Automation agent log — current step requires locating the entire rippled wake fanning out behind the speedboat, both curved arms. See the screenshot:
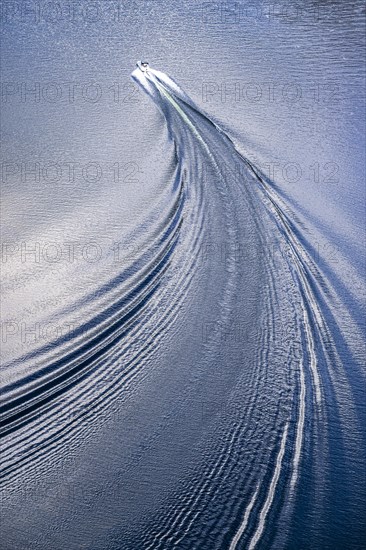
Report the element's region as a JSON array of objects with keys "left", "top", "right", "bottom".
[{"left": 0, "top": 63, "right": 365, "bottom": 550}]
